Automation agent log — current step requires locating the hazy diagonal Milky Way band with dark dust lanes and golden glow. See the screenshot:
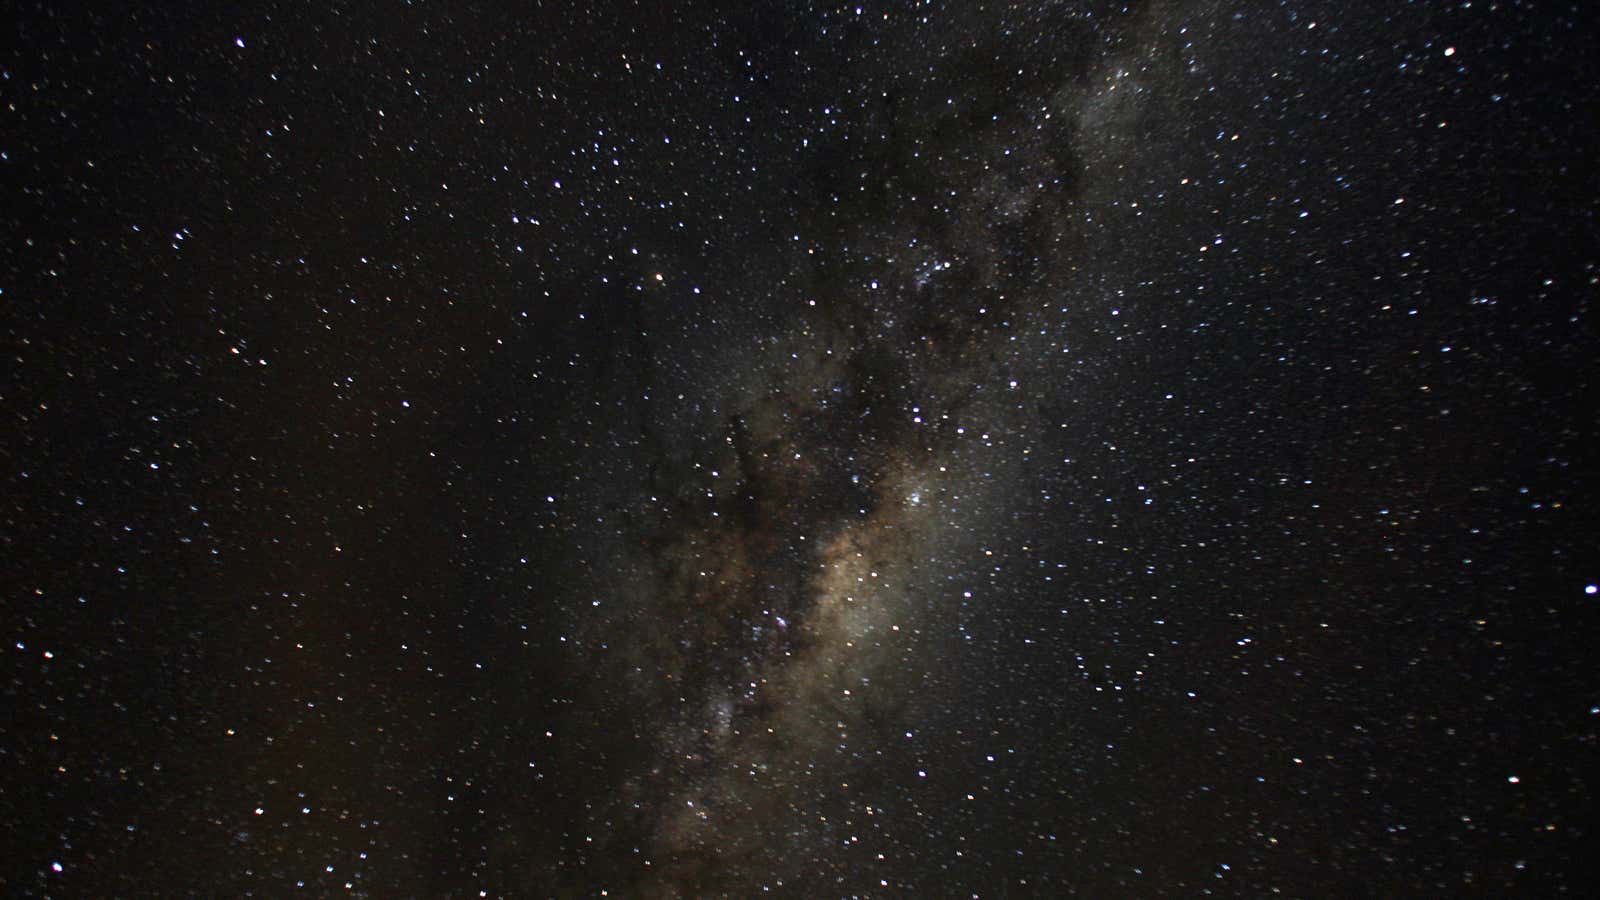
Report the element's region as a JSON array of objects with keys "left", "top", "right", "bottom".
[{"left": 550, "top": 11, "right": 1174, "bottom": 894}]
